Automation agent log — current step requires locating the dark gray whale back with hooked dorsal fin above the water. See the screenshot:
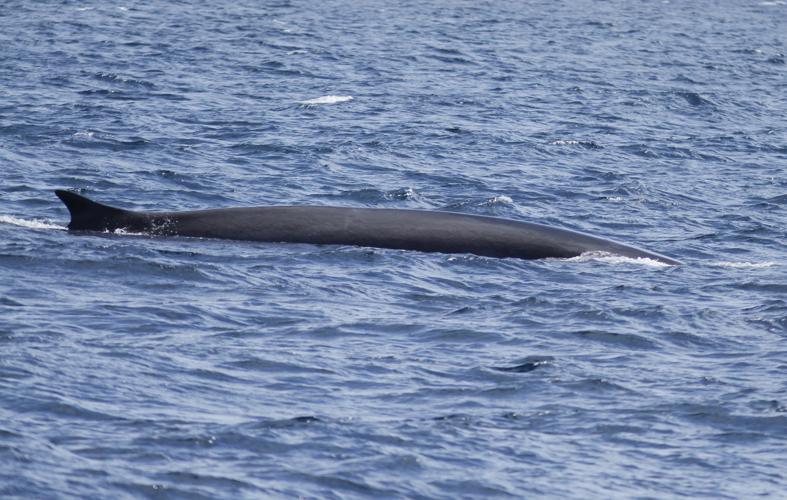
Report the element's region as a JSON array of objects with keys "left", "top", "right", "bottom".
[{"left": 55, "top": 190, "right": 680, "bottom": 265}]
